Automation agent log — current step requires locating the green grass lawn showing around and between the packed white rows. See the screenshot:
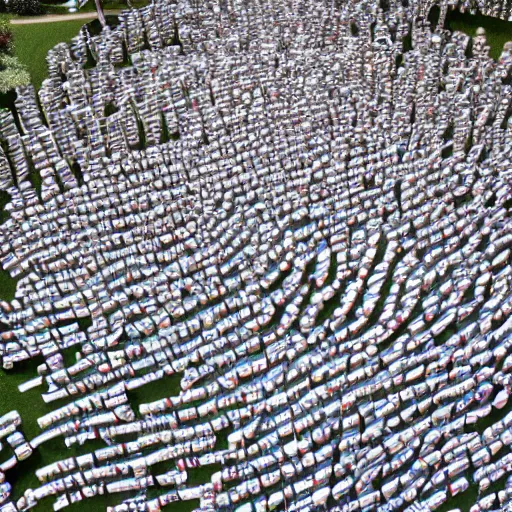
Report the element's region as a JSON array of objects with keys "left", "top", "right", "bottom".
[{"left": 0, "top": 7, "right": 512, "bottom": 512}]
